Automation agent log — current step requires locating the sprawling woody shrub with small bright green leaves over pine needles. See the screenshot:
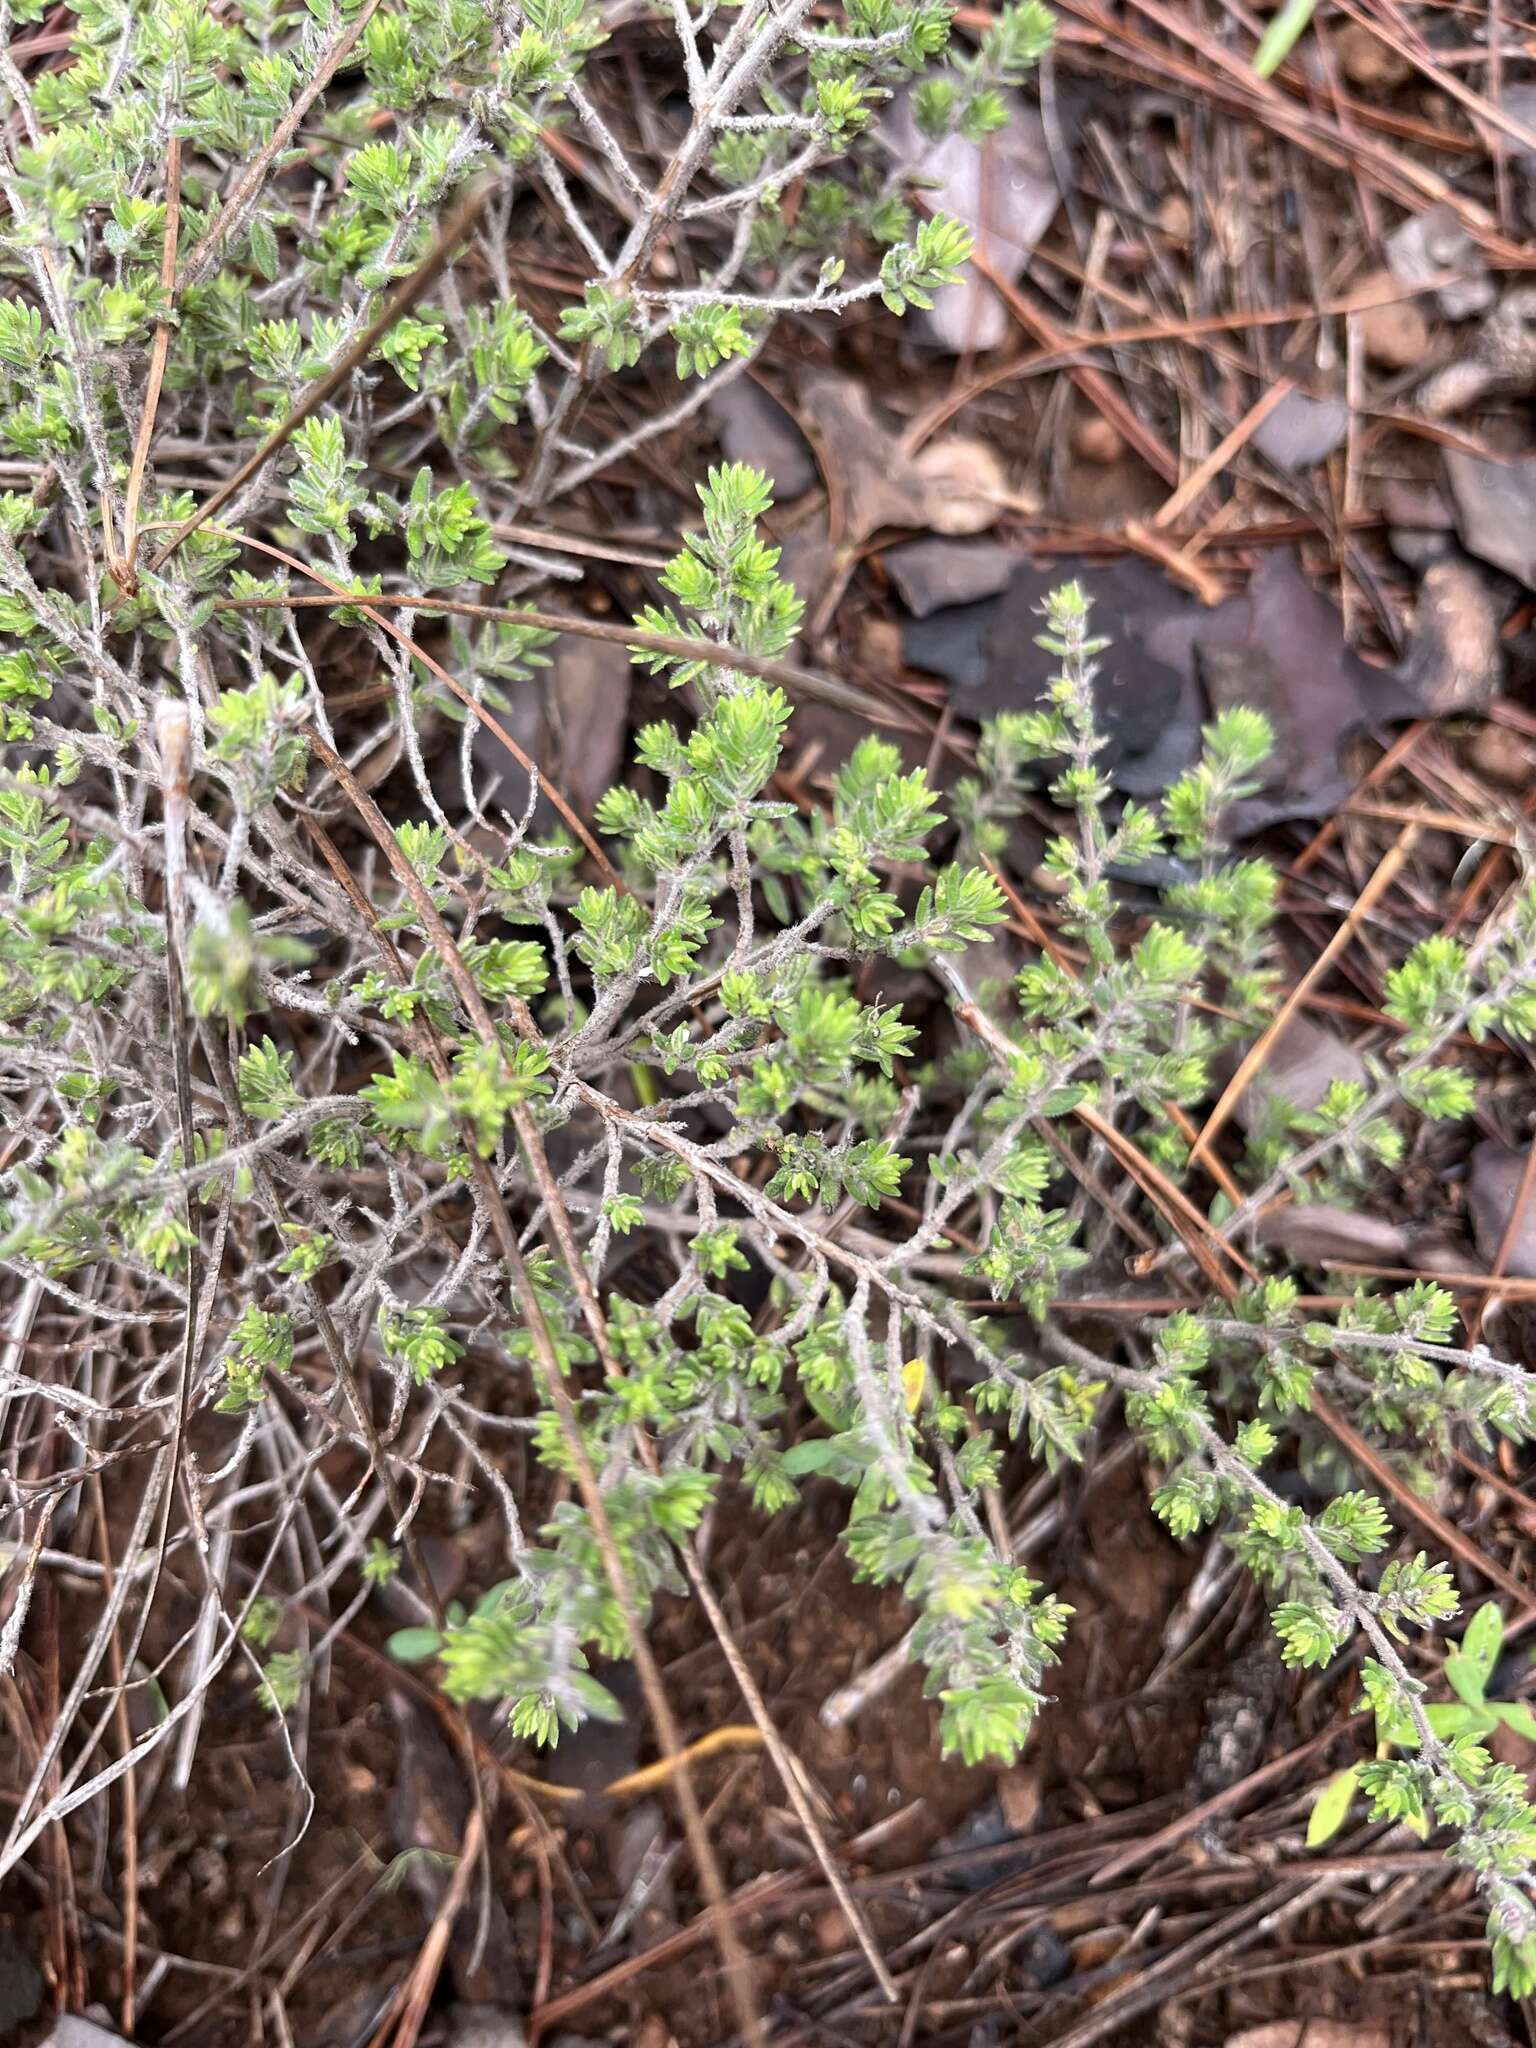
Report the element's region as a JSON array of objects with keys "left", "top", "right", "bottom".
[{"left": 0, "top": 0, "right": 1536, "bottom": 1993}]
